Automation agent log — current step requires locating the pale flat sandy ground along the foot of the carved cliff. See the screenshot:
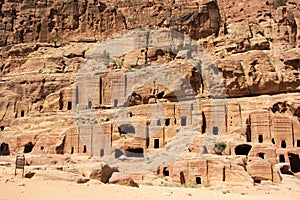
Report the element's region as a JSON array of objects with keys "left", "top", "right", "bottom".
[{"left": 0, "top": 176, "right": 300, "bottom": 200}]
